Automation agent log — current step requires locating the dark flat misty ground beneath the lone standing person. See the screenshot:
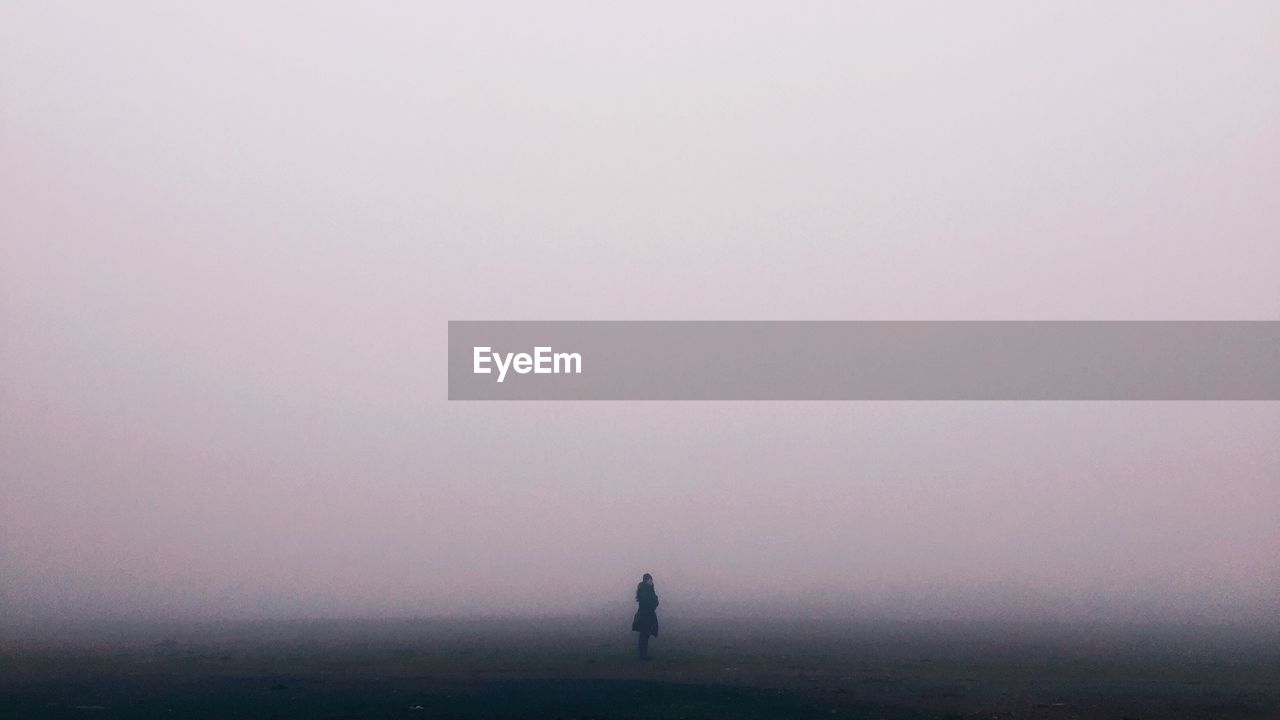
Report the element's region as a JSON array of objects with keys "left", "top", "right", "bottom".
[{"left": 0, "top": 616, "right": 1280, "bottom": 720}]
